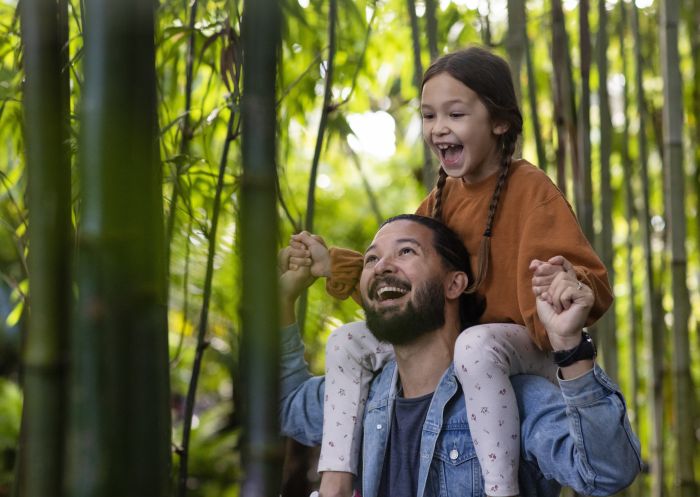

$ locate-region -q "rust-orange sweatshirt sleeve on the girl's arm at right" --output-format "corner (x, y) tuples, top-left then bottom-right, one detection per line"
(517, 193), (613, 350)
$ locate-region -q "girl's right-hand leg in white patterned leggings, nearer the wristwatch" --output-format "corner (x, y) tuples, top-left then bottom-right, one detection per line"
(455, 323), (556, 496)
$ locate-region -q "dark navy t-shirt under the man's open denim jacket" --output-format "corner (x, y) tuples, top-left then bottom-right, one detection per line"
(379, 393), (433, 497)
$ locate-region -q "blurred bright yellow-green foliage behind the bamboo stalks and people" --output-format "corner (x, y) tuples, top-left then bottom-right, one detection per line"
(0, 0), (700, 496)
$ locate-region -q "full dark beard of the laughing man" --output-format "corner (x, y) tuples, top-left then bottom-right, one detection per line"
(362, 278), (445, 345)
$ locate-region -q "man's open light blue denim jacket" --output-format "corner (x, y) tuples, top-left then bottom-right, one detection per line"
(280, 325), (641, 497)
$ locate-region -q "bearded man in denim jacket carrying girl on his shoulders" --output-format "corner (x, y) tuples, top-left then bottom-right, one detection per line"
(280, 215), (640, 497)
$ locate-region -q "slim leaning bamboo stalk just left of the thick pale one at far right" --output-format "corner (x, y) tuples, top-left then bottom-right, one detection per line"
(631, 5), (666, 497)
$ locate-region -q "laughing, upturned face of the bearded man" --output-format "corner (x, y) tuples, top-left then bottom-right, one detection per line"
(360, 220), (445, 345)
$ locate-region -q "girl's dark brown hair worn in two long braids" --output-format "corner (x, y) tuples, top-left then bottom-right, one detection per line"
(421, 47), (523, 291)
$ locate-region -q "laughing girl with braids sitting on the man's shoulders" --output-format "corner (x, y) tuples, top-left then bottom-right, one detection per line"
(289, 47), (612, 497)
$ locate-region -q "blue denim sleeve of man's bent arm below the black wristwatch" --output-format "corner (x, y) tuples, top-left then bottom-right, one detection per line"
(512, 365), (641, 495)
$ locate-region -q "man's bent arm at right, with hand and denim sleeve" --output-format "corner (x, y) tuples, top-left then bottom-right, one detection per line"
(524, 261), (641, 495)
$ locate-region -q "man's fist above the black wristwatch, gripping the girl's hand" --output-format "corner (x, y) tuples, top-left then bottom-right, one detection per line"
(530, 261), (595, 350)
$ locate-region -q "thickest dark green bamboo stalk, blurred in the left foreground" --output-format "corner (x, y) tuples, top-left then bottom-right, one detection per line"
(67, 0), (171, 497)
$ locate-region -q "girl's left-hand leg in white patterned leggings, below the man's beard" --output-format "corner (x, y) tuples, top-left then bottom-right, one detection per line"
(318, 321), (394, 474)
